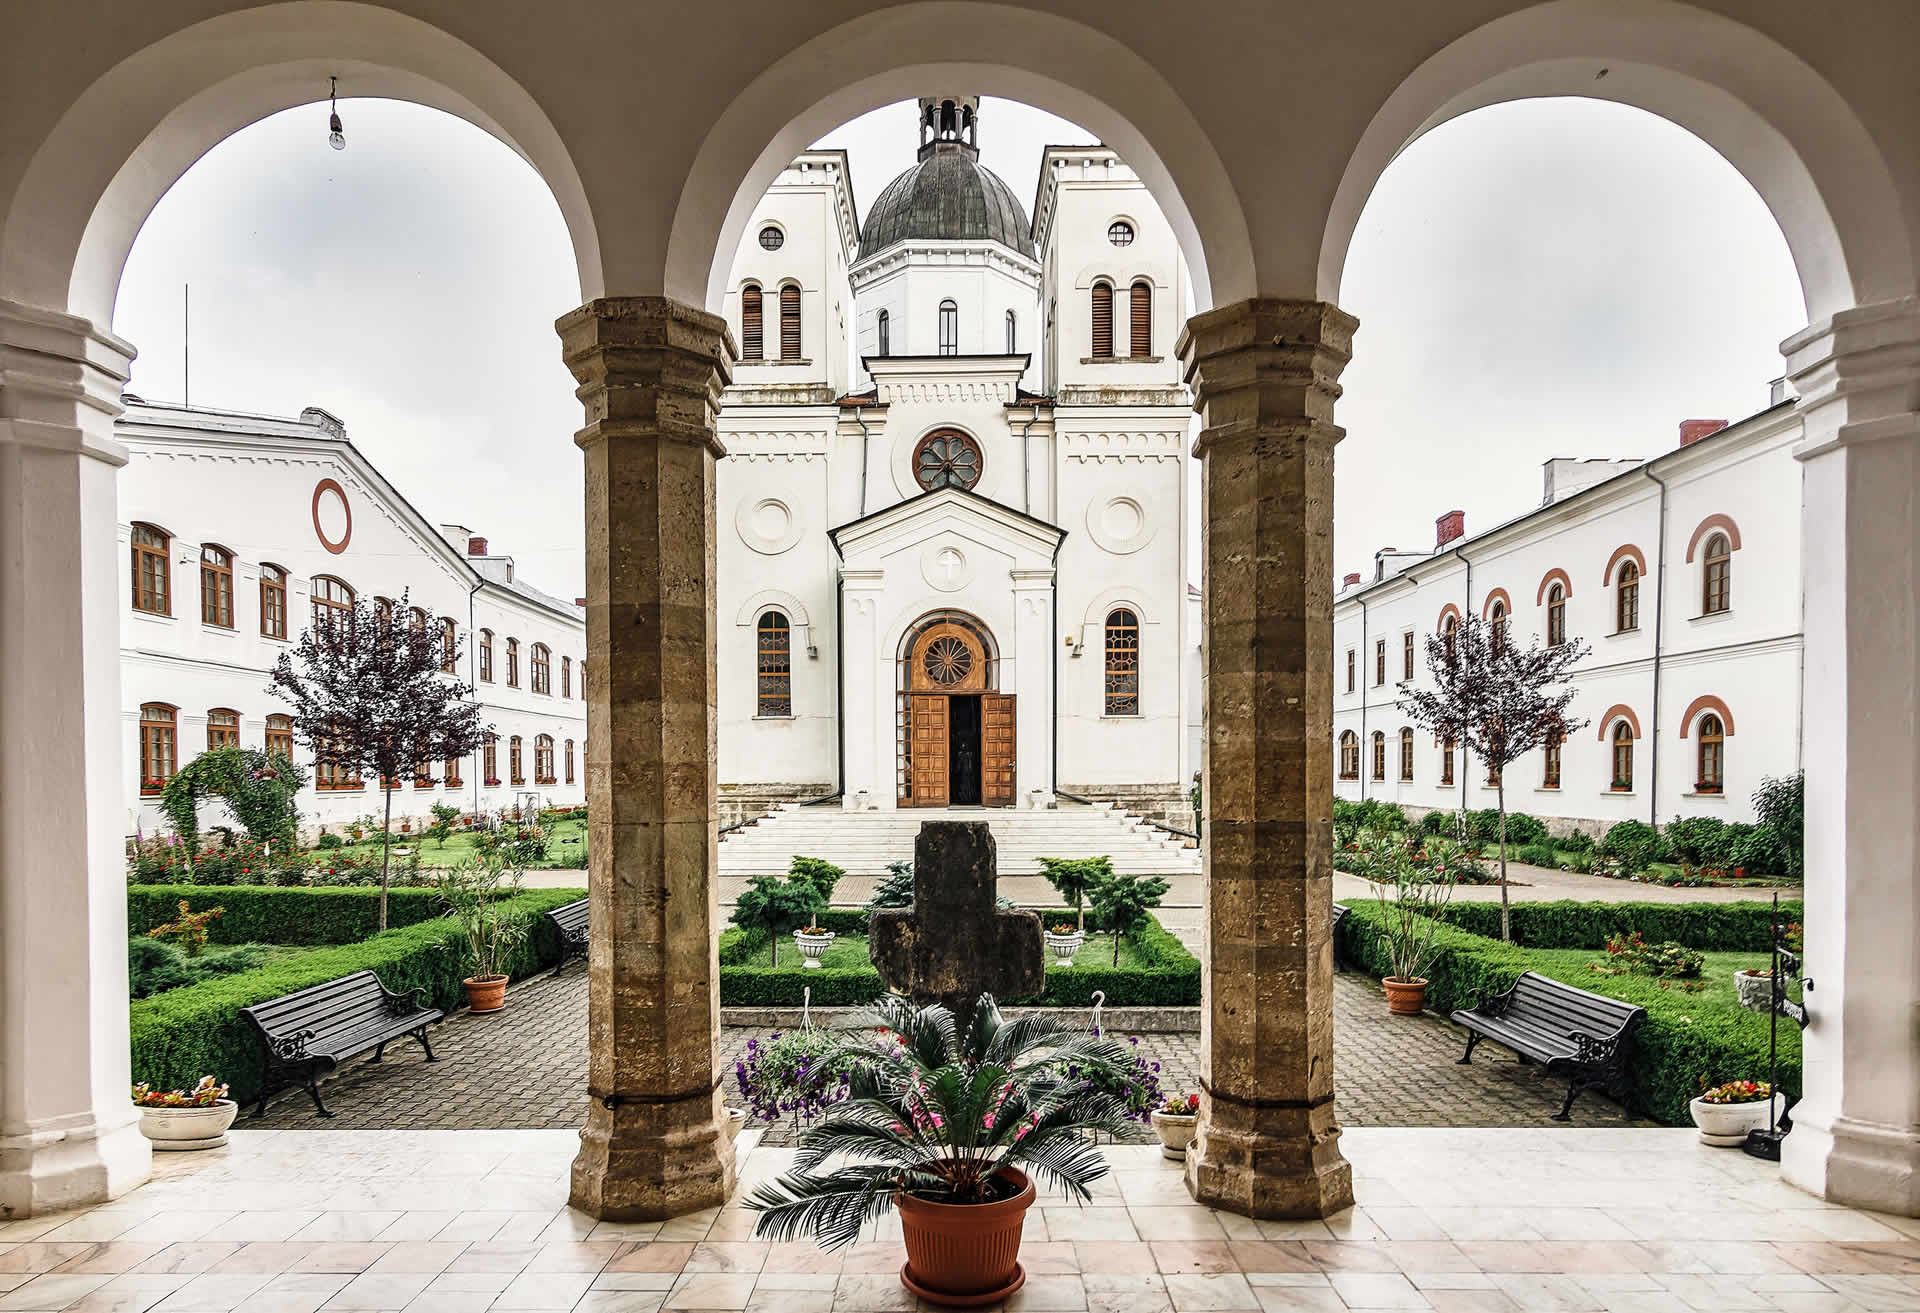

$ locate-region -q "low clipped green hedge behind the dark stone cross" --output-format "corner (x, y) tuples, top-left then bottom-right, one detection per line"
(720, 908), (1200, 1008)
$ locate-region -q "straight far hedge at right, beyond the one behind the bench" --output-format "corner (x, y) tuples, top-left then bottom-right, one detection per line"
(1440, 902), (1803, 952)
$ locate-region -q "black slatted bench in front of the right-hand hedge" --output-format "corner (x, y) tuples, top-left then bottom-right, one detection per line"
(1453, 971), (1647, 1121)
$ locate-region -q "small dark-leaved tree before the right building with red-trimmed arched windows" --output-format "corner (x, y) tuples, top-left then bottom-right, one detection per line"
(1400, 616), (1588, 941)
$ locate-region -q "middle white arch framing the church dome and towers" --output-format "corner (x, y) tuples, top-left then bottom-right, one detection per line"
(664, 0), (1258, 311)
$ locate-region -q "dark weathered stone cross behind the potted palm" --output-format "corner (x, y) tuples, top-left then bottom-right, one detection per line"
(868, 822), (1046, 1031)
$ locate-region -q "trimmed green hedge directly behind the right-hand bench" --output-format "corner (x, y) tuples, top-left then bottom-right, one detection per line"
(1340, 902), (1801, 1127)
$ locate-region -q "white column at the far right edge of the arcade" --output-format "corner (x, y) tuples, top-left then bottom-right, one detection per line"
(1774, 298), (1920, 1217)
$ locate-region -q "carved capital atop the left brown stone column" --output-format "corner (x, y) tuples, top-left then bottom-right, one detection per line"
(553, 296), (735, 457)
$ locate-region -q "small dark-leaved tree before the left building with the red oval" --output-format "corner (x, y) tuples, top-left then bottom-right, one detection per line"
(267, 593), (493, 929)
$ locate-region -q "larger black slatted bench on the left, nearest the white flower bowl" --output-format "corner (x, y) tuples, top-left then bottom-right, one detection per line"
(240, 971), (445, 1117)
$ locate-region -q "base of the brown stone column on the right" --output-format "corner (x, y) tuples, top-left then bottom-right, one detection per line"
(1187, 1098), (1354, 1219)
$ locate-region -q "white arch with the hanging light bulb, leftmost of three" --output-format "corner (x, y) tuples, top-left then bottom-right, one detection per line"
(0, 0), (605, 326)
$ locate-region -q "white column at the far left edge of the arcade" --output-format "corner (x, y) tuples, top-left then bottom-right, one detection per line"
(0, 301), (152, 1219)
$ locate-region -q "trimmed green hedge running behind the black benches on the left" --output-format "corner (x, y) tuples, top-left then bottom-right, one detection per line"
(131, 889), (580, 1102)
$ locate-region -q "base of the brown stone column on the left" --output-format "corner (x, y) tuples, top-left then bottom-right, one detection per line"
(566, 1096), (735, 1221)
